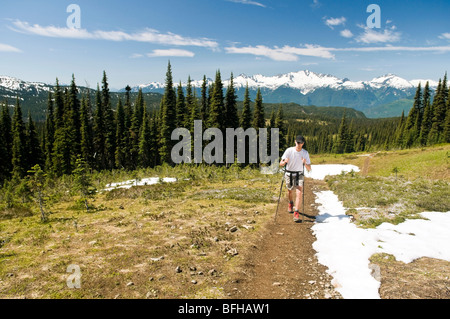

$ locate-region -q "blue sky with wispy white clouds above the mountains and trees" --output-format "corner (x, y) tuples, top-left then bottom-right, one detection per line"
(0, 0), (450, 89)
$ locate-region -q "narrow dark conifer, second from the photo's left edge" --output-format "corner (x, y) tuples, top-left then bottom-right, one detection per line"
(12, 97), (27, 178)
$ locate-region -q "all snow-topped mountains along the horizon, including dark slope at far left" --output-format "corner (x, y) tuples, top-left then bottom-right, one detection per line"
(0, 70), (438, 118)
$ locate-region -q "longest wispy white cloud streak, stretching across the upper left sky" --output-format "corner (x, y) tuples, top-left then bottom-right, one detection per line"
(11, 20), (219, 49)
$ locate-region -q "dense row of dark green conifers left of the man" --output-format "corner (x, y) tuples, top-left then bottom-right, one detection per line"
(0, 62), (284, 185)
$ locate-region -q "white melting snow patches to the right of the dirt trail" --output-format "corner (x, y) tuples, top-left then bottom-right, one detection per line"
(306, 165), (450, 299)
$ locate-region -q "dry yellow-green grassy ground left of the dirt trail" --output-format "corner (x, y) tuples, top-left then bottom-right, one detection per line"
(0, 171), (279, 298)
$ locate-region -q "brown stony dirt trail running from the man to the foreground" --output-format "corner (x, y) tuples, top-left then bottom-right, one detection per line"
(225, 179), (341, 299)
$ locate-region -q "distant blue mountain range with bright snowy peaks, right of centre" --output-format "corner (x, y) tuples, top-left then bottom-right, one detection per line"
(126, 70), (438, 118)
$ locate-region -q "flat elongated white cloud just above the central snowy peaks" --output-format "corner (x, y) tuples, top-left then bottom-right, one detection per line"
(225, 44), (334, 62)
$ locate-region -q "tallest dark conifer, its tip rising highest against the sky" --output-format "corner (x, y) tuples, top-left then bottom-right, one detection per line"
(159, 61), (177, 163)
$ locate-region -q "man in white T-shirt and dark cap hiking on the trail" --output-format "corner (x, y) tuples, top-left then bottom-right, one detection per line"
(280, 135), (311, 222)
